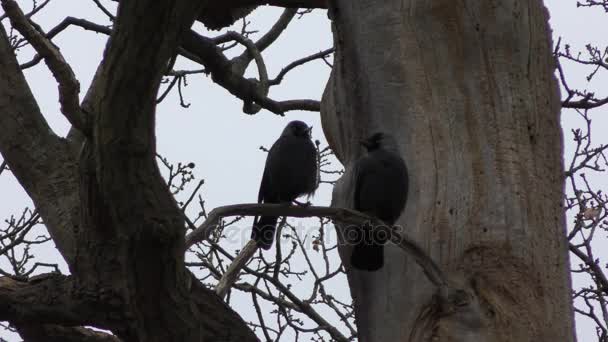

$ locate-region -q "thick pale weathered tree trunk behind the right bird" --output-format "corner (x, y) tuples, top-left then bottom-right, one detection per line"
(322, 0), (574, 342)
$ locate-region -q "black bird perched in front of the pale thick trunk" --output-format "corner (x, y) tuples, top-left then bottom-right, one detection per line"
(350, 132), (408, 271)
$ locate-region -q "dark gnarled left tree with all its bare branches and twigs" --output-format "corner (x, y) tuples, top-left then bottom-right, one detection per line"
(0, 1), (355, 341)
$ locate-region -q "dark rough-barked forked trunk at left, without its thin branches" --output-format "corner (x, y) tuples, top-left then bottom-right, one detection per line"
(0, 0), (257, 341)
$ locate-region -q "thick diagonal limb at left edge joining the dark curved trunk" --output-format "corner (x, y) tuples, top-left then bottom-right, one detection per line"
(0, 22), (79, 267)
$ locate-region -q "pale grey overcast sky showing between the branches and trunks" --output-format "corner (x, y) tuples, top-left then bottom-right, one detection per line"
(0, 0), (608, 341)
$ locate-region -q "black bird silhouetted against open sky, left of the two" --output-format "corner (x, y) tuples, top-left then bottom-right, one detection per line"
(251, 120), (319, 249)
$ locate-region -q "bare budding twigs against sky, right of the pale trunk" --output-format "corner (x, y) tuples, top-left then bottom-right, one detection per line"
(554, 0), (608, 342)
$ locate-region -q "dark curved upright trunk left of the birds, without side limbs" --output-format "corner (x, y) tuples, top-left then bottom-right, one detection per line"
(78, 0), (255, 342)
